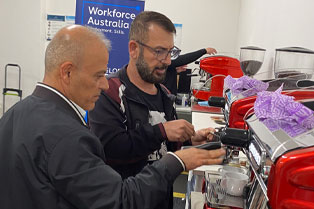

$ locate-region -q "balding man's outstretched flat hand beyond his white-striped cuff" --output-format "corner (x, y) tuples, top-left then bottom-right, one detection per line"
(175, 148), (226, 171)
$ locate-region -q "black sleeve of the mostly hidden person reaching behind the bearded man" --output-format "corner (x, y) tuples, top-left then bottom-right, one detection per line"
(163, 49), (207, 95)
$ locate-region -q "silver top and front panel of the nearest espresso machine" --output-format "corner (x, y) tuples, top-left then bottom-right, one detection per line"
(243, 115), (314, 209)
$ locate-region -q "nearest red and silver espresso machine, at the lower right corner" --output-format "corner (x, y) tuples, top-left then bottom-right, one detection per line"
(204, 99), (314, 209)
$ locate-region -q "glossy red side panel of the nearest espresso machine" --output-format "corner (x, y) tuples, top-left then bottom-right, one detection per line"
(267, 147), (314, 209)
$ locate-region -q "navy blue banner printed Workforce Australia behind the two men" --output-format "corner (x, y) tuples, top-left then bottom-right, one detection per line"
(75, 0), (145, 74)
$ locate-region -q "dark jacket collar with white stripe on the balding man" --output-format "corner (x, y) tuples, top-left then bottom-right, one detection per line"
(32, 83), (87, 127)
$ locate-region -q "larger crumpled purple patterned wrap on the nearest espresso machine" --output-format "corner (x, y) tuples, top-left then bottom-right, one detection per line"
(254, 86), (314, 137)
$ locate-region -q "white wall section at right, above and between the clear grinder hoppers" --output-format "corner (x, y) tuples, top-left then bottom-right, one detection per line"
(237, 0), (314, 78)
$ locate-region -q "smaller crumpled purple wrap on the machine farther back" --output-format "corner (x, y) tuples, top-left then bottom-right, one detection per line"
(224, 75), (268, 97)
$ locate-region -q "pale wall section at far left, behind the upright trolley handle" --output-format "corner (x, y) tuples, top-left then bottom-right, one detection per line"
(0, 0), (45, 115)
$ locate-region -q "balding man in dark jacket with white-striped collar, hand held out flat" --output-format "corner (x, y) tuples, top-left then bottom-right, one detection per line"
(0, 25), (224, 209)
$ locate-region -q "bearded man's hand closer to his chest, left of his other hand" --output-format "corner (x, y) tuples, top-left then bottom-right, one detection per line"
(163, 119), (195, 142)
